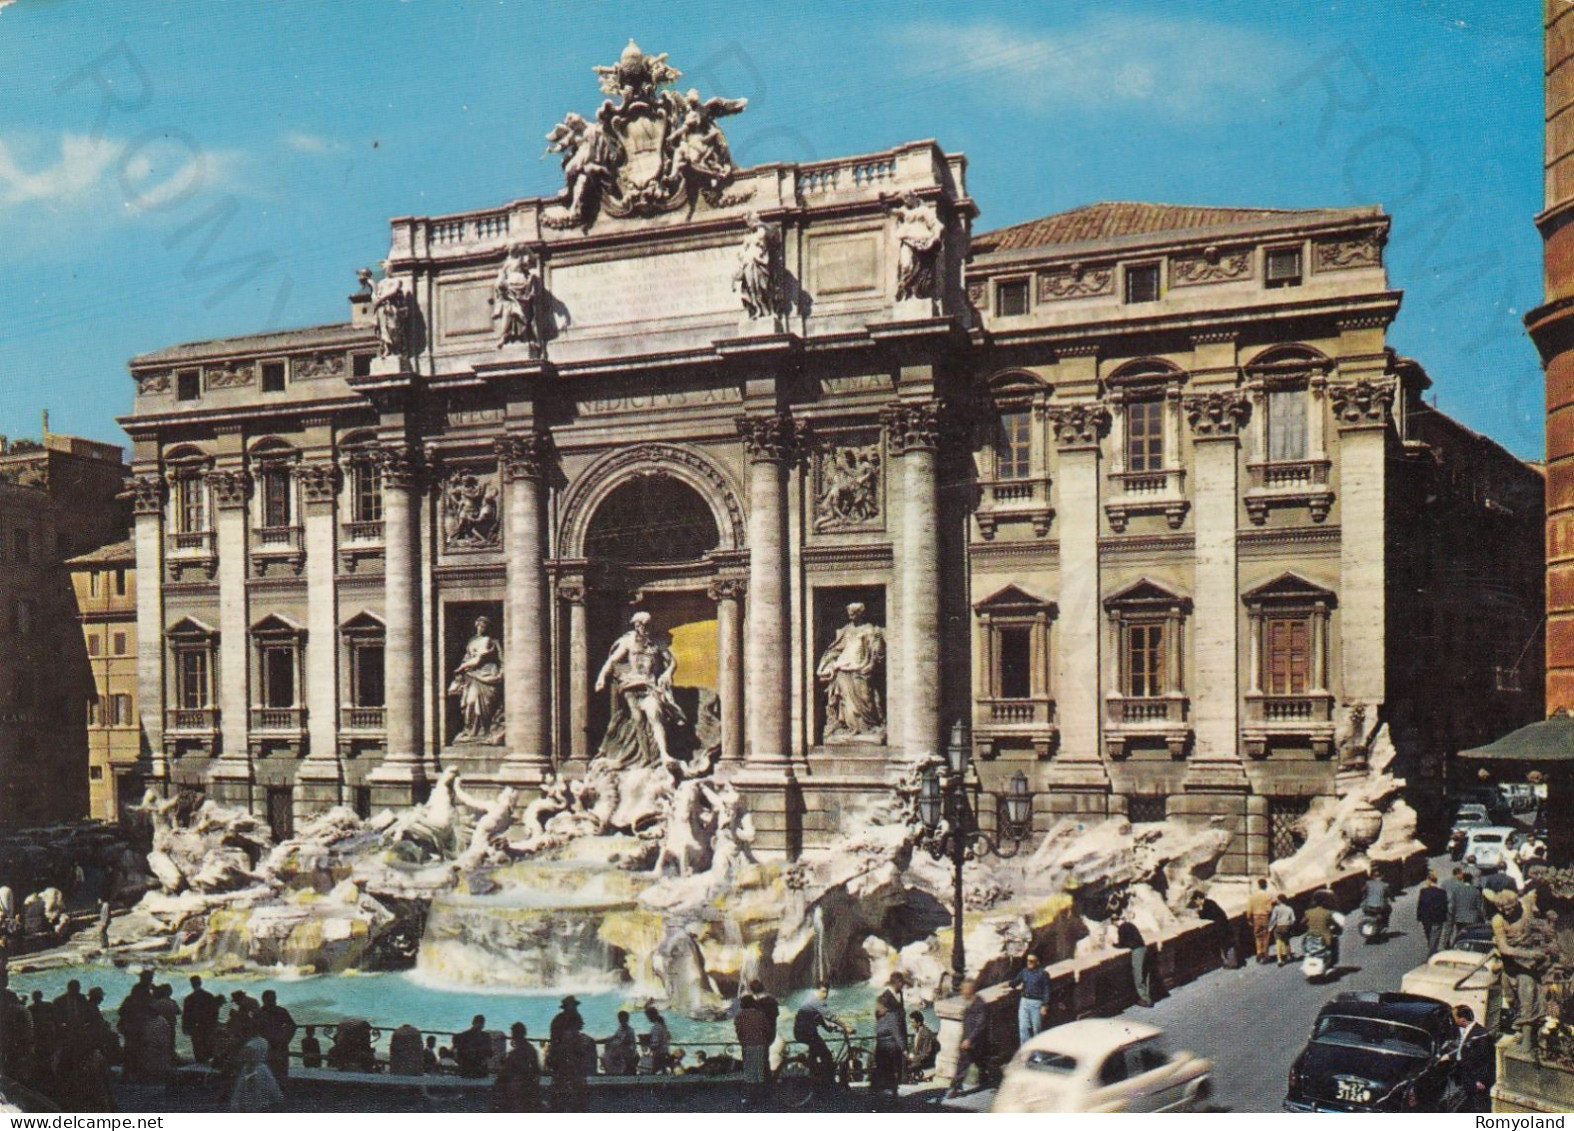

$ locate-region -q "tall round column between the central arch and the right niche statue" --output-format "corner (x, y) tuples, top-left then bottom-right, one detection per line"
(738, 412), (798, 766)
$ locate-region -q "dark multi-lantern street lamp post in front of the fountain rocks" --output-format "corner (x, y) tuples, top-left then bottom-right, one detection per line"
(918, 719), (1033, 993)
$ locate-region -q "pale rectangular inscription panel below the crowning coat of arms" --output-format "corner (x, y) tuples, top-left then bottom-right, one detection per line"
(549, 245), (743, 332)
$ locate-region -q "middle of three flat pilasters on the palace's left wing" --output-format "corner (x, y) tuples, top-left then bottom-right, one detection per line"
(208, 467), (252, 807)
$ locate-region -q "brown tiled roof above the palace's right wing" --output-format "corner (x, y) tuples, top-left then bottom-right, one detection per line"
(973, 200), (1382, 252)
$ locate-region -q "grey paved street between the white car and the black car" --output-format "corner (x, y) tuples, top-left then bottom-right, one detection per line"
(1121, 859), (1447, 1112)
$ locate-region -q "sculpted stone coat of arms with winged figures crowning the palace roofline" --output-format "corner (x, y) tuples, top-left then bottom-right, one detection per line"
(543, 39), (748, 228)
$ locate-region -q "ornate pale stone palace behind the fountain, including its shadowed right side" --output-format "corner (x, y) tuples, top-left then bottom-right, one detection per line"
(123, 46), (1541, 871)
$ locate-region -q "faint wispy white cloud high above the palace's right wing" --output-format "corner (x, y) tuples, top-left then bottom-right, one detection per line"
(897, 14), (1283, 118)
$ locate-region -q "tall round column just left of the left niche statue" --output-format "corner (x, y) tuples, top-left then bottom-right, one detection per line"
(368, 447), (422, 804)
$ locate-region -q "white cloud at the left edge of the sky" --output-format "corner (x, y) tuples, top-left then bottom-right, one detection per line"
(0, 134), (241, 216)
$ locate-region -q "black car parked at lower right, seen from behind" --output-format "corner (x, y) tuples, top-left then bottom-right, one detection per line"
(1284, 993), (1465, 1112)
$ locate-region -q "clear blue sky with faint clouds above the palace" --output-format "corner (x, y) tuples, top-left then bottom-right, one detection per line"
(0, 0), (1543, 458)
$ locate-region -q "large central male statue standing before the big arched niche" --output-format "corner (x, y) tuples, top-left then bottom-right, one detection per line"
(595, 612), (686, 769)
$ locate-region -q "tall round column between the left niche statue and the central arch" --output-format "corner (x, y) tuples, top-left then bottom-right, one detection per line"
(497, 436), (552, 782)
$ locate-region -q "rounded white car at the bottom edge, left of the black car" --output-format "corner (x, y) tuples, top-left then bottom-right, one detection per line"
(990, 1018), (1214, 1112)
